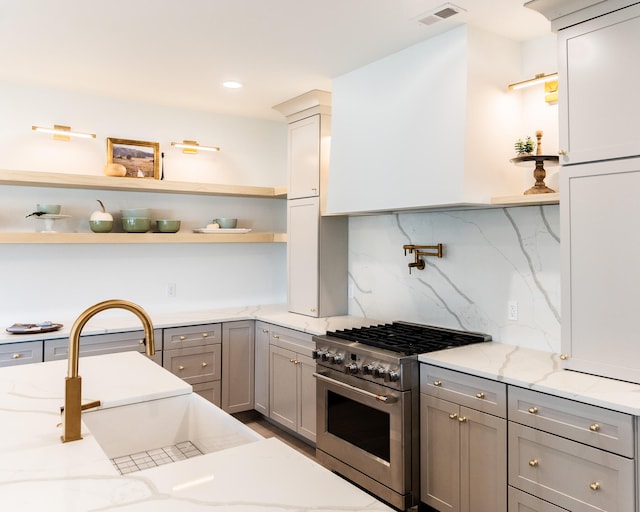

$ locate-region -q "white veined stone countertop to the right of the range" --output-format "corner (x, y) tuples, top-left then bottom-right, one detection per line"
(418, 342), (640, 416)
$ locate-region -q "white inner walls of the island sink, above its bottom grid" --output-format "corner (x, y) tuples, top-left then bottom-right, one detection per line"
(82, 393), (263, 459)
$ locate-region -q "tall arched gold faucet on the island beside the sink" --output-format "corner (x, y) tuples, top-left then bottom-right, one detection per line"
(60, 299), (155, 443)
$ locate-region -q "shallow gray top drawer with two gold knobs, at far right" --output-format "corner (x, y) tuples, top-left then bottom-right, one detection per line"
(509, 386), (634, 457)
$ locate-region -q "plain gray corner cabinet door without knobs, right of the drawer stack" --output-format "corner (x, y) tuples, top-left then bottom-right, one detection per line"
(222, 320), (255, 413)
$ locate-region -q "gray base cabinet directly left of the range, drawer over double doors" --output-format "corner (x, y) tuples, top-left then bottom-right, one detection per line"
(269, 326), (316, 443)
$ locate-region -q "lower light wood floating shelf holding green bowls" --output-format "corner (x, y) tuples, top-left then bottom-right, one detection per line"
(0, 232), (287, 244)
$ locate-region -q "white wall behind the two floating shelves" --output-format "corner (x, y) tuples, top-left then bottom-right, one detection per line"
(0, 83), (287, 325)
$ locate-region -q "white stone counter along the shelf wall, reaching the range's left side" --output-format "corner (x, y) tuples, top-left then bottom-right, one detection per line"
(0, 304), (381, 345)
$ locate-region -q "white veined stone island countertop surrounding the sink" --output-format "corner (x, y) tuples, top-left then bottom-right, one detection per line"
(0, 352), (391, 512)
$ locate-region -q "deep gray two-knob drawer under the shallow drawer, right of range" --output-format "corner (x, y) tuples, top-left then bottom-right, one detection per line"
(508, 422), (635, 512)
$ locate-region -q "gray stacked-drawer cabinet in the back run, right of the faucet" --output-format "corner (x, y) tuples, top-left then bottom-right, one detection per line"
(163, 324), (222, 406)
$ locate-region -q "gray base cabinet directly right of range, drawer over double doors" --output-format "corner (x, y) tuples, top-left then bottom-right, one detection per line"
(420, 365), (507, 512)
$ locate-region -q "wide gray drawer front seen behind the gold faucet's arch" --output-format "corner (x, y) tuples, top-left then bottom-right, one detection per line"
(44, 329), (162, 362)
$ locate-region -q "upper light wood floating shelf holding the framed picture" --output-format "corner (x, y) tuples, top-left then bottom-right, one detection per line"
(0, 170), (287, 199)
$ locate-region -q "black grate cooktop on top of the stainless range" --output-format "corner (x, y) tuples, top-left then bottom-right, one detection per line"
(327, 322), (491, 356)
